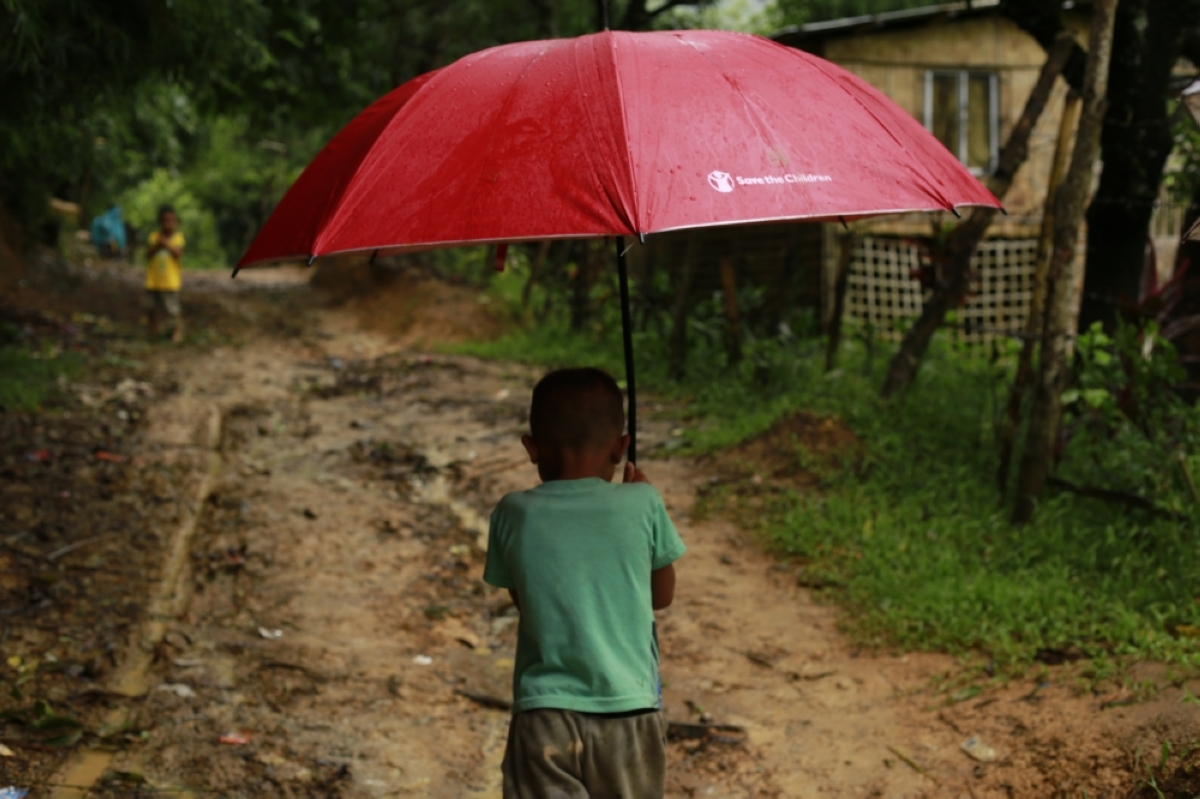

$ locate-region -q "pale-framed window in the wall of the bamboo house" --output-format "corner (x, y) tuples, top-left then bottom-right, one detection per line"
(925, 70), (1000, 175)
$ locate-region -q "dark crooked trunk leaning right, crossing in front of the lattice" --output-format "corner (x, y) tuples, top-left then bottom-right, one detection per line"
(882, 34), (1076, 400)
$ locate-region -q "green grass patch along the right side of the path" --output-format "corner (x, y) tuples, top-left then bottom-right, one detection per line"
(462, 307), (1200, 672)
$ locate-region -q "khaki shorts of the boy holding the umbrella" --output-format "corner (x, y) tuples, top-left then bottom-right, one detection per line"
(502, 709), (667, 799)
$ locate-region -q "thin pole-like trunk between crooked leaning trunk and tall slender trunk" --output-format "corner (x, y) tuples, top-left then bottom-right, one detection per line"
(996, 89), (1080, 493)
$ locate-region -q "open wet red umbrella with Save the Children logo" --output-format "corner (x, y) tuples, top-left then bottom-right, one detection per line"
(234, 30), (1000, 459)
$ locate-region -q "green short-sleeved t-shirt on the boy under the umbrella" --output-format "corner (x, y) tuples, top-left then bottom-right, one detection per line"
(484, 477), (685, 713)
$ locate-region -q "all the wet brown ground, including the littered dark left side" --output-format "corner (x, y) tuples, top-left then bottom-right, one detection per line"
(0, 257), (1200, 799)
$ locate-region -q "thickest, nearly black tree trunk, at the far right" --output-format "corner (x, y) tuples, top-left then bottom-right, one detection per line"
(1079, 0), (1200, 329)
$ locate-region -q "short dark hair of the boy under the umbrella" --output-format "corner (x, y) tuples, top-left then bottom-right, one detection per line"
(529, 367), (625, 450)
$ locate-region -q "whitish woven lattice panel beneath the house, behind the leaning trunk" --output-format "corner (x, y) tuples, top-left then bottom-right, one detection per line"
(846, 231), (1037, 344)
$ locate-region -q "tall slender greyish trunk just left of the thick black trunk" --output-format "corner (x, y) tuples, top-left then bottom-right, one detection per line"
(1013, 0), (1117, 524)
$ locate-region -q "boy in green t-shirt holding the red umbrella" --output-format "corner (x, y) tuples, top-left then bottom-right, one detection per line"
(484, 368), (684, 799)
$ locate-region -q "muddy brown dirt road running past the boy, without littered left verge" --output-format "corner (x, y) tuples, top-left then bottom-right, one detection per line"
(4, 262), (1198, 799)
